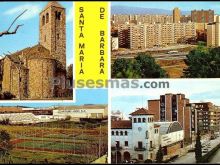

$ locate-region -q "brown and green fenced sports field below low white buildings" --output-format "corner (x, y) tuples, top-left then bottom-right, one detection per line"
(0, 121), (108, 163)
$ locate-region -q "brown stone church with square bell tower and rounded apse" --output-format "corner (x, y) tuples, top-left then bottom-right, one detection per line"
(1, 1), (69, 99)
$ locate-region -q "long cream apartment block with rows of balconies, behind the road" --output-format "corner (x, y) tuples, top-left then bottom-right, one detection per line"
(118, 22), (196, 49)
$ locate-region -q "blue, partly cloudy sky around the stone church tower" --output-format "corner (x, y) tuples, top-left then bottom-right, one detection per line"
(0, 1), (73, 65)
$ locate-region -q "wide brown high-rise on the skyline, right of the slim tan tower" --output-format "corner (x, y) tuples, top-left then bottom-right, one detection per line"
(191, 10), (214, 23)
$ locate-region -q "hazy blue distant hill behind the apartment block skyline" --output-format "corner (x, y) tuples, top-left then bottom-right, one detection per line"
(111, 6), (191, 15)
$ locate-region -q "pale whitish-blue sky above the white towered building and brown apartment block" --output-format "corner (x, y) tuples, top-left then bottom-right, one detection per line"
(110, 79), (220, 117)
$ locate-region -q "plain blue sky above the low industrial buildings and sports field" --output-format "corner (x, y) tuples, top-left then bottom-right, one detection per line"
(0, 89), (108, 107)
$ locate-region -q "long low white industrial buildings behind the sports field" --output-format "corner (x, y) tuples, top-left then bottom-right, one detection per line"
(0, 104), (108, 124)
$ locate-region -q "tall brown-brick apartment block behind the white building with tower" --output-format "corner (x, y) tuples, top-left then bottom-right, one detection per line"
(148, 93), (191, 139)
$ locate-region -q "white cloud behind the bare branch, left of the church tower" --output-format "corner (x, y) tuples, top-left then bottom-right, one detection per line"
(4, 3), (41, 20)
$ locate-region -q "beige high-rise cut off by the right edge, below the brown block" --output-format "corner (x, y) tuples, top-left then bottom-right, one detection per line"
(207, 16), (220, 47)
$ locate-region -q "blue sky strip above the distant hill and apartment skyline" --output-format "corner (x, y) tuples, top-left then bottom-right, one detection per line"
(111, 1), (220, 14)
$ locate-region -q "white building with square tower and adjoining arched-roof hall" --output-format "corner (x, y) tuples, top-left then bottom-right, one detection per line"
(111, 108), (184, 163)
